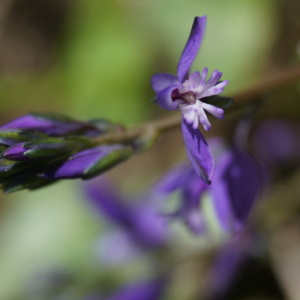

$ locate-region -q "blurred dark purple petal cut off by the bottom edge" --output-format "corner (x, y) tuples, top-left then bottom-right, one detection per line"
(107, 278), (165, 300)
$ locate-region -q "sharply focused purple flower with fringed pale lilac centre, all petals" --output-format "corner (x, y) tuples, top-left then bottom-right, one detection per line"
(151, 16), (228, 183)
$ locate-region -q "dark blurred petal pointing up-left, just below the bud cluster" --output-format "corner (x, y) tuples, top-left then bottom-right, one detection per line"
(86, 178), (132, 226)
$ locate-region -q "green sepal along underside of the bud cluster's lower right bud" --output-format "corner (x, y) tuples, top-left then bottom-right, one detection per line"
(82, 146), (134, 179)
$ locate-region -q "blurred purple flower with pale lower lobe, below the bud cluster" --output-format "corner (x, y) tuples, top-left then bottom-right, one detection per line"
(86, 178), (168, 264)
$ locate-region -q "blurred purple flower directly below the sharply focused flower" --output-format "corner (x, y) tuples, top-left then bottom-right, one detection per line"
(157, 142), (262, 235)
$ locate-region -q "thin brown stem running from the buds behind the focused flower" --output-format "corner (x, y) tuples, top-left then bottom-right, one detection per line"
(94, 65), (300, 144)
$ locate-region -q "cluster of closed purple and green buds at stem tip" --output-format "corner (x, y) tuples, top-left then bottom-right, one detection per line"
(0, 113), (133, 193)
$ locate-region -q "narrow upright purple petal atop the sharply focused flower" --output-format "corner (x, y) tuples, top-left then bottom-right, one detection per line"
(177, 16), (206, 82)
